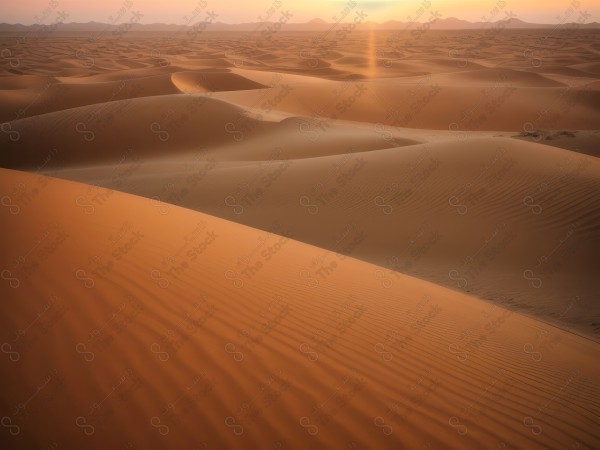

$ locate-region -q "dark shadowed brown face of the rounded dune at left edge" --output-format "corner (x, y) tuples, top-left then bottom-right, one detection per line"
(2, 94), (276, 167)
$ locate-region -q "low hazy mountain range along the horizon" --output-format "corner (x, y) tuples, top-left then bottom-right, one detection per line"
(0, 17), (600, 35)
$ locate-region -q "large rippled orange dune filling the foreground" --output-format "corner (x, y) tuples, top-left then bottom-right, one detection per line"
(0, 170), (600, 449)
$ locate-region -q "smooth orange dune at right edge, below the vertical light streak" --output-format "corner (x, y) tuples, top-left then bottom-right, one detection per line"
(211, 66), (600, 131)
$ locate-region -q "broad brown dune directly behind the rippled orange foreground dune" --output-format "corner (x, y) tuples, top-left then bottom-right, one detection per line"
(38, 135), (600, 340)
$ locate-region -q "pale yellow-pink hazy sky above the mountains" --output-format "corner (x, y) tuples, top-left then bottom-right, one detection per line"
(0, 0), (600, 24)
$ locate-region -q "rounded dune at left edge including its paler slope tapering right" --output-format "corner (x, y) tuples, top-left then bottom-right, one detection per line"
(0, 92), (432, 170)
